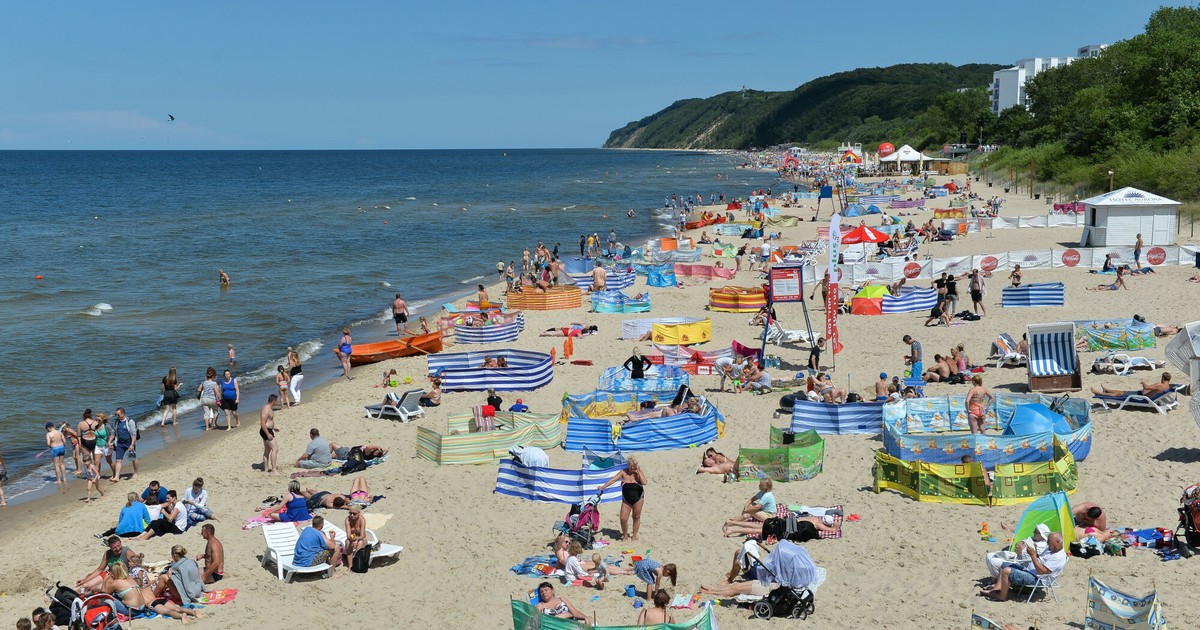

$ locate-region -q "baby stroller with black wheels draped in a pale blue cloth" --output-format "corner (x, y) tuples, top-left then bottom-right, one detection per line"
(748, 540), (817, 620)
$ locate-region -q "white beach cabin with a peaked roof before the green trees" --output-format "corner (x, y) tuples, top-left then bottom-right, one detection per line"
(1082, 187), (1180, 247)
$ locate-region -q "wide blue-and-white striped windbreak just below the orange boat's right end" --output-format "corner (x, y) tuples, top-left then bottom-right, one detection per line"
(427, 349), (554, 391)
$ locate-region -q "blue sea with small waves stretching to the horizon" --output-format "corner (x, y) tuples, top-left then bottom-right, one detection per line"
(0, 149), (778, 502)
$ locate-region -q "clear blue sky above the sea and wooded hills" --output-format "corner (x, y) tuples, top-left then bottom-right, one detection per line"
(0, 0), (1172, 149)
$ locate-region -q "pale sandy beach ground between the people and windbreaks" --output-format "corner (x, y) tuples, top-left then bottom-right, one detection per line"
(0, 176), (1200, 629)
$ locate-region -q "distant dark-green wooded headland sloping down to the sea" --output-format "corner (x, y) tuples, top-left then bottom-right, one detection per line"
(605, 64), (1004, 149)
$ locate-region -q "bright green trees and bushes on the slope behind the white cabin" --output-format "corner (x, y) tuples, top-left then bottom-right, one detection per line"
(979, 7), (1200, 200)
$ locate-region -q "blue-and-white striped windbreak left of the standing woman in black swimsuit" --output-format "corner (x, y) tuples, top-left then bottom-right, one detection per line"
(496, 460), (625, 504)
